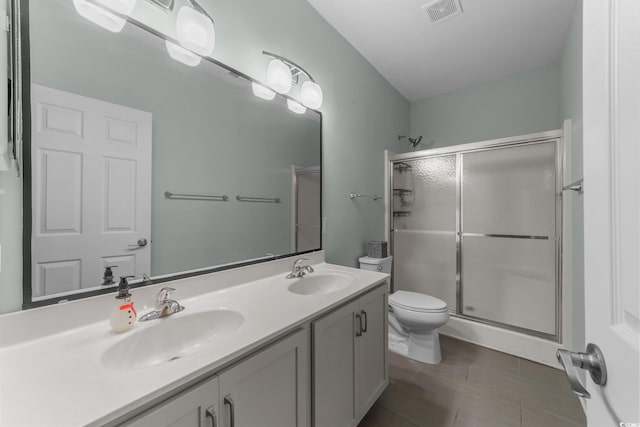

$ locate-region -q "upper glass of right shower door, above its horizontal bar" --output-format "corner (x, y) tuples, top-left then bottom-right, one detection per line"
(462, 142), (556, 236)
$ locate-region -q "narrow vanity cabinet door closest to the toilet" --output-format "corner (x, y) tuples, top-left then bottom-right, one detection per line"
(357, 286), (389, 415)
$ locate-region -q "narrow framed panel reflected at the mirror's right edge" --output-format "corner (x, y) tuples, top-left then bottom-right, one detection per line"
(292, 166), (321, 252)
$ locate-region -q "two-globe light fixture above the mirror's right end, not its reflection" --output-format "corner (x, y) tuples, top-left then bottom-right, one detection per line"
(262, 51), (323, 108)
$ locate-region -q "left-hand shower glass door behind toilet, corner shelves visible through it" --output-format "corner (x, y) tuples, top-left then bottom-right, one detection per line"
(392, 154), (458, 310)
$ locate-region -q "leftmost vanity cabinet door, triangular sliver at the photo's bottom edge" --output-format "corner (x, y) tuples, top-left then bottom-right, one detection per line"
(124, 377), (219, 427)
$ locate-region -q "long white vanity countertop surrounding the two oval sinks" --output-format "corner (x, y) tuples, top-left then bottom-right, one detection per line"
(0, 259), (387, 427)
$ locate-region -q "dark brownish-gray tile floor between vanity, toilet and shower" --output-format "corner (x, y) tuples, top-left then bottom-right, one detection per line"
(358, 336), (586, 427)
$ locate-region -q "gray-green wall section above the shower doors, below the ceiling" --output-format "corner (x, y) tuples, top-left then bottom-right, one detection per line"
(410, 63), (562, 149)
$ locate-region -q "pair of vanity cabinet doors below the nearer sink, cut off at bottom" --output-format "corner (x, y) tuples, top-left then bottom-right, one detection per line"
(124, 329), (311, 427)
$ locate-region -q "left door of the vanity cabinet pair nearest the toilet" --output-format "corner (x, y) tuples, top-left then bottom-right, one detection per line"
(312, 301), (359, 427)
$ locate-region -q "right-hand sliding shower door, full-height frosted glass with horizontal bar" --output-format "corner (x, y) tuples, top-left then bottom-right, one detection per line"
(460, 140), (559, 336)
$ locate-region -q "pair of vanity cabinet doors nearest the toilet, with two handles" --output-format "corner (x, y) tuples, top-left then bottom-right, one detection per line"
(312, 284), (389, 427)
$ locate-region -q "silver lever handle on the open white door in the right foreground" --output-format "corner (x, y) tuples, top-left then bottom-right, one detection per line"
(556, 343), (607, 399)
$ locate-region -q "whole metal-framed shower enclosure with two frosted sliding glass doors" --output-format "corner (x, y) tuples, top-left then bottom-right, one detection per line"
(388, 133), (563, 341)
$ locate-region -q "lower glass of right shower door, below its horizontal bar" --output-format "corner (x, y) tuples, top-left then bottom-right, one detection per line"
(462, 236), (556, 334)
